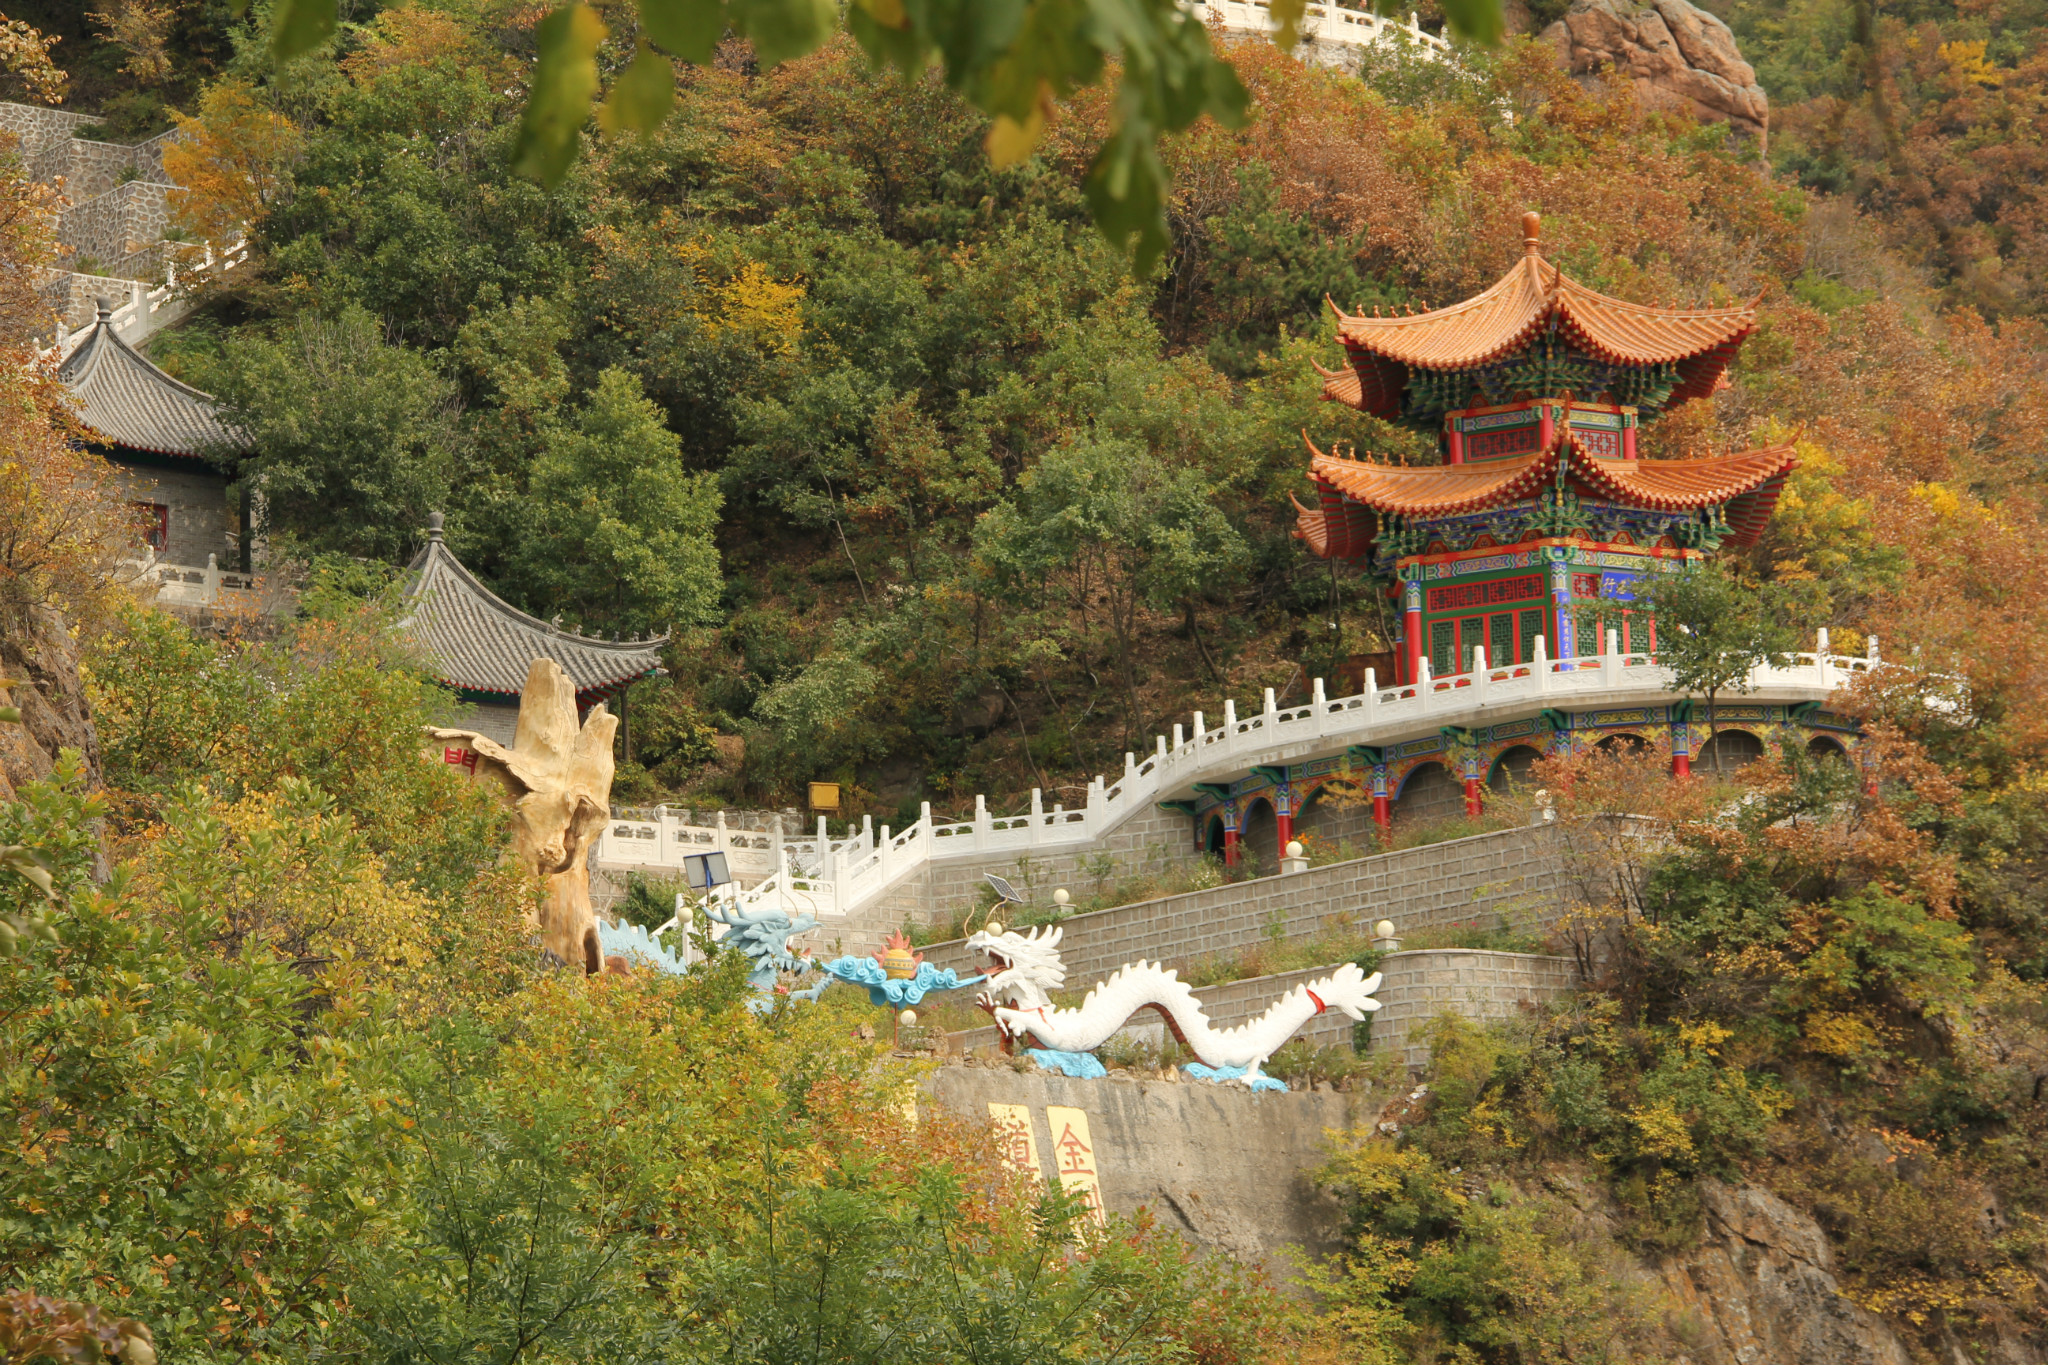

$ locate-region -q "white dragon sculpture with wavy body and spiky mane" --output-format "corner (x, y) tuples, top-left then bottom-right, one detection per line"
(967, 925), (1380, 1085)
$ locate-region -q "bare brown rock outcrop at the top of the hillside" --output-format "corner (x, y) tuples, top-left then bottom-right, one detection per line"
(1540, 0), (1772, 141)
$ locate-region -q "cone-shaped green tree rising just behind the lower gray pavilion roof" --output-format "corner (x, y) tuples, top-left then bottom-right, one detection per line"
(508, 368), (723, 634)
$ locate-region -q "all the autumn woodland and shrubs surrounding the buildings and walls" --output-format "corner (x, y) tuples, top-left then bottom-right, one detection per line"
(12, 0), (2048, 1365)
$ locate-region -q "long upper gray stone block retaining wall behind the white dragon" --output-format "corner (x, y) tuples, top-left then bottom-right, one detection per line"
(924, 829), (1565, 988)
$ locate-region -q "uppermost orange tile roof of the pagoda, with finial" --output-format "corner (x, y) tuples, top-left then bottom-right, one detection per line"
(1331, 213), (1757, 376)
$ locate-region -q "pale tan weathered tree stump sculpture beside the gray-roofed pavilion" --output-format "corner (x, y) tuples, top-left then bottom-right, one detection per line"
(428, 659), (618, 974)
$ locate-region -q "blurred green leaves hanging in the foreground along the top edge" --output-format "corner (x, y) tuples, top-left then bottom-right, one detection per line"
(229, 0), (1503, 276)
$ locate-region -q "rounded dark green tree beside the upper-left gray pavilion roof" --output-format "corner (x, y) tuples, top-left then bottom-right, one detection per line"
(215, 307), (463, 559)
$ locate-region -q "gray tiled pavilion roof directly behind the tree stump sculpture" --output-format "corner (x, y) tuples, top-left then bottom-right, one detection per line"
(399, 512), (668, 696)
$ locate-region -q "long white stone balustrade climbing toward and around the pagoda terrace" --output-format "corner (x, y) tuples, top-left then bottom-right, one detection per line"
(596, 630), (1878, 917)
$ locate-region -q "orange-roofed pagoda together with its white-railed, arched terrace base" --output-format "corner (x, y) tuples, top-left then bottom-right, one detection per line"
(1159, 213), (1855, 875)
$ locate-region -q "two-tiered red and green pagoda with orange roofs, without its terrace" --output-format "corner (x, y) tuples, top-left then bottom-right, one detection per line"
(1294, 213), (1794, 684)
